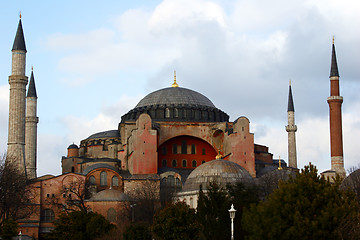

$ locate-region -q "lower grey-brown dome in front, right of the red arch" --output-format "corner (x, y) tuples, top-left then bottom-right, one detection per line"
(183, 159), (254, 192)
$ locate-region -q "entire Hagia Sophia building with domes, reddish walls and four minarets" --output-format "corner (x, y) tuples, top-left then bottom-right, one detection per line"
(7, 16), (345, 238)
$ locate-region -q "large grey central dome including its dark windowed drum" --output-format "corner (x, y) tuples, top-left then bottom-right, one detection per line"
(121, 87), (229, 122)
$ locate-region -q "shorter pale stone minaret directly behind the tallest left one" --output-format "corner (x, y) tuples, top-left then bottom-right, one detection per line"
(25, 68), (39, 179)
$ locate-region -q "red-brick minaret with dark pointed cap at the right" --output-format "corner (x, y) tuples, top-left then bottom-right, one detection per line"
(327, 38), (346, 177)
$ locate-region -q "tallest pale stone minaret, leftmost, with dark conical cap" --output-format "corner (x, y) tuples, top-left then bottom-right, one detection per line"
(7, 14), (28, 172)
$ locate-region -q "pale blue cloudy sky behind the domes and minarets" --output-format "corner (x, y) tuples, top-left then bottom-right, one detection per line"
(0, 0), (360, 176)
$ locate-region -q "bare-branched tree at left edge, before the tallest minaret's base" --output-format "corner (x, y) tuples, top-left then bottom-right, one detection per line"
(0, 154), (34, 225)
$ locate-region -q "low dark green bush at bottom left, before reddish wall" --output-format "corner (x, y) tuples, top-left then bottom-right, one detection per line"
(46, 211), (114, 240)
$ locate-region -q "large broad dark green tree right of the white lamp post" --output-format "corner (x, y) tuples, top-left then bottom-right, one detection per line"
(243, 164), (358, 240)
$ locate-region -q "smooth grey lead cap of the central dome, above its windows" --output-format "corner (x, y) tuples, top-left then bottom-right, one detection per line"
(135, 87), (215, 108)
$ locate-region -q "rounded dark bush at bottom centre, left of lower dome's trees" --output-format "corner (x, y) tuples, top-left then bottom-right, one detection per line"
(152, 202), (200, 240)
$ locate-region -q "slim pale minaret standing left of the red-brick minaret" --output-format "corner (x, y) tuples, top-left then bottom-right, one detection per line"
(286, 81), (297, 168)
